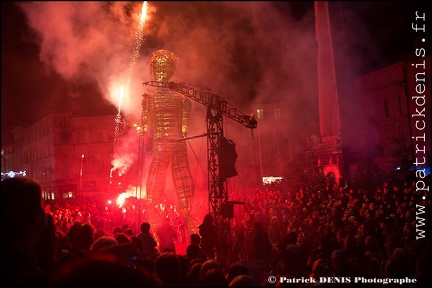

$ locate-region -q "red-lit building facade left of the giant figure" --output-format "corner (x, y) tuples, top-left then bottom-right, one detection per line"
(2, 113), (115, 199)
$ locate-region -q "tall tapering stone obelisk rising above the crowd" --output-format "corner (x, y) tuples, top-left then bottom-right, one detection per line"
(314, 1), (362, 182)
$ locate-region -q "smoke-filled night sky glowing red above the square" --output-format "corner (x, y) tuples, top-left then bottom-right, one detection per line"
(1, 1), (428, 146)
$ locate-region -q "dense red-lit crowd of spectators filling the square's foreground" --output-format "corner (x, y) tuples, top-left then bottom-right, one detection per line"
(1, 178), (432, 287)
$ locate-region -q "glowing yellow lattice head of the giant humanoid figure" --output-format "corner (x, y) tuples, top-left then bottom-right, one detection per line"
(150, 49), (177, 82)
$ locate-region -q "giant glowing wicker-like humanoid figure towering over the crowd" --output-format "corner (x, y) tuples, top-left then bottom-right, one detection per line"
(141, 49), (194, 214)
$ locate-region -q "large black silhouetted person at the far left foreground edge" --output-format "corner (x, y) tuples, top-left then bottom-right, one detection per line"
(0, 177), (49, 287)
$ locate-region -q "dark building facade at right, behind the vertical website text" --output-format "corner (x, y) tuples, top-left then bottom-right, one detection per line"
(356, 56), (431, 171)
